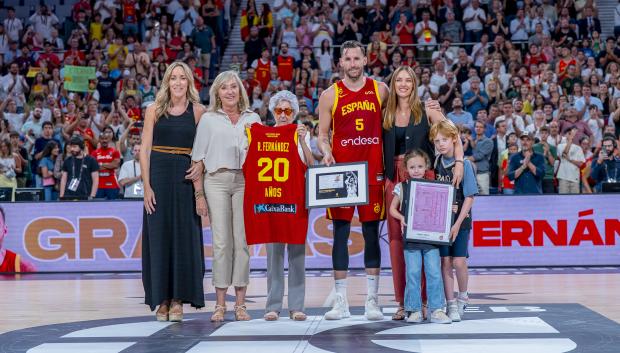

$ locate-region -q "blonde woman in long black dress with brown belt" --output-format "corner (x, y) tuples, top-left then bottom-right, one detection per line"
(140, 62), (207, 321)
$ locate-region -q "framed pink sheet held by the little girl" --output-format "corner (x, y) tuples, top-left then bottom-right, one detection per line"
(405, 179), (455, 245)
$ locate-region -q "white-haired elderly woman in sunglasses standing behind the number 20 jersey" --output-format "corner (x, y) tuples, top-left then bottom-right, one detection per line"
(264, 91), (314, 321)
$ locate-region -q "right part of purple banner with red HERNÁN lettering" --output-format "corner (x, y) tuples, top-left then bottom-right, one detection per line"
(469, 194), (620, 266)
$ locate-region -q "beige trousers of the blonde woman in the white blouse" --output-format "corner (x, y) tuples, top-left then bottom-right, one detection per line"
(204, 169), (250, 288)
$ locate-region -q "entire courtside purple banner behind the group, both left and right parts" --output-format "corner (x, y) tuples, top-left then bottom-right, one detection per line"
(0, 194), (620, 272)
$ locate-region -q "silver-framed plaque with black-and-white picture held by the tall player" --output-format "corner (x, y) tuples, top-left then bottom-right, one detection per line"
(306, 162), (368, 208)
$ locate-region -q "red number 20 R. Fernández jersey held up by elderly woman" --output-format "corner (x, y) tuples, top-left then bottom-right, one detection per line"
(243, 124), (308, 245)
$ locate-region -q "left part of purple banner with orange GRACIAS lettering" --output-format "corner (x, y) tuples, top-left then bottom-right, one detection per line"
(0, 201), (378, 272)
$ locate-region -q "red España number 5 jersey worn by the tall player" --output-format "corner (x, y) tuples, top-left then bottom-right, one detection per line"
(332, 78), (383, 185)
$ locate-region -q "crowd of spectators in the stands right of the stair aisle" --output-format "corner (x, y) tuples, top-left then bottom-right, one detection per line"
(237, 0), (620, 194)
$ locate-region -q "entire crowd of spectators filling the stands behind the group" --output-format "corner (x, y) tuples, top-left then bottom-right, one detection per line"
(0, 0), (620, 200)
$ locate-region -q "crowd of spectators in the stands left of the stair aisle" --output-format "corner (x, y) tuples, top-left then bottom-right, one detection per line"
(0, 0), (239, 200)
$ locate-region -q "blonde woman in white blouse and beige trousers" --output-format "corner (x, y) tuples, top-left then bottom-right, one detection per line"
(192, 71), (261, 322)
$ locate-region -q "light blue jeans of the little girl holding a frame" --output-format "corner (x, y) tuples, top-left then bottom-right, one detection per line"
(405, 248), (446, 313)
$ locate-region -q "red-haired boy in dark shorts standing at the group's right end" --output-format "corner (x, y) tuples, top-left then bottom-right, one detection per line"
(430, 120), (478, 322)
